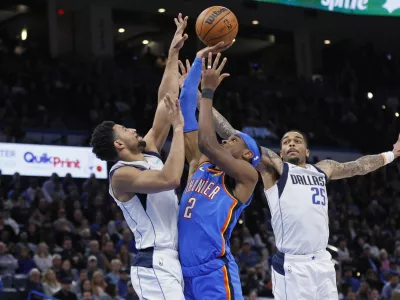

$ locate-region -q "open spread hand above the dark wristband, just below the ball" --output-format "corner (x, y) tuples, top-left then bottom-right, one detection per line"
(201, 52), (230, 91)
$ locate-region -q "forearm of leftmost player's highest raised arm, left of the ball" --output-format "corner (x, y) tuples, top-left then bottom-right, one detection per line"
(158, 49), (179, 102)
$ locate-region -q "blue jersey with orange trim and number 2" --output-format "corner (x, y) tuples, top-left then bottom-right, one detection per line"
(178, 162), (253, 267)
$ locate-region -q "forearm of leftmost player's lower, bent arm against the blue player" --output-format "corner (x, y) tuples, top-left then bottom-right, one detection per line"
(163, 127), (185, 185)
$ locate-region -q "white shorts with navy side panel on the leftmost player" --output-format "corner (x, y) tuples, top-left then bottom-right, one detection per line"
(131, 249), (185, 300)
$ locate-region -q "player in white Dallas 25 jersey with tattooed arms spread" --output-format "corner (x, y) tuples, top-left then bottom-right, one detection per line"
(180, 63), (400, 300)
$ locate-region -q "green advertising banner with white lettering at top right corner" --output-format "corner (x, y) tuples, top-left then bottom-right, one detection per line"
(256, 0), (400, 17)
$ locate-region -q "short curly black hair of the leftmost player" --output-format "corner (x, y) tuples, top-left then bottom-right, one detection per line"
(90, 121), (118, 161)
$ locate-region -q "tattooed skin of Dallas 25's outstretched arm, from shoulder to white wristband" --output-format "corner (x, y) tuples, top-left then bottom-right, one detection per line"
(317, 154), (385, 180)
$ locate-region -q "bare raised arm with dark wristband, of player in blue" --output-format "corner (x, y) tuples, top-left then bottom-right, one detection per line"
(199, 54), (258, 202)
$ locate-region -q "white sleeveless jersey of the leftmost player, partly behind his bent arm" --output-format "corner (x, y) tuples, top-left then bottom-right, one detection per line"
(109, 153), (179, 250)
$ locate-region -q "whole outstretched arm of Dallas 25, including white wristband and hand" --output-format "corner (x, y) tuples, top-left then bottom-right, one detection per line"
(316, 136), (400, 180)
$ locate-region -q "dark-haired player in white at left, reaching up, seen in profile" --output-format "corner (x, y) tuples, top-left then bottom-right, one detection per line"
(91, 14), (187, 300)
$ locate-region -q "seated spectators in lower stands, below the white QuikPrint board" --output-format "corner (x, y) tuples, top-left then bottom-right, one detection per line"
(0, 158), (400, 300)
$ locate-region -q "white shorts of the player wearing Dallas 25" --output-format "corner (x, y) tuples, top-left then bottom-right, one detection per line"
(272, 250), (339, 300)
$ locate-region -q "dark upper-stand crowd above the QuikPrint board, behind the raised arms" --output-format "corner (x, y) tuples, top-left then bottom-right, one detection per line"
(0, 41), (400, 152)
